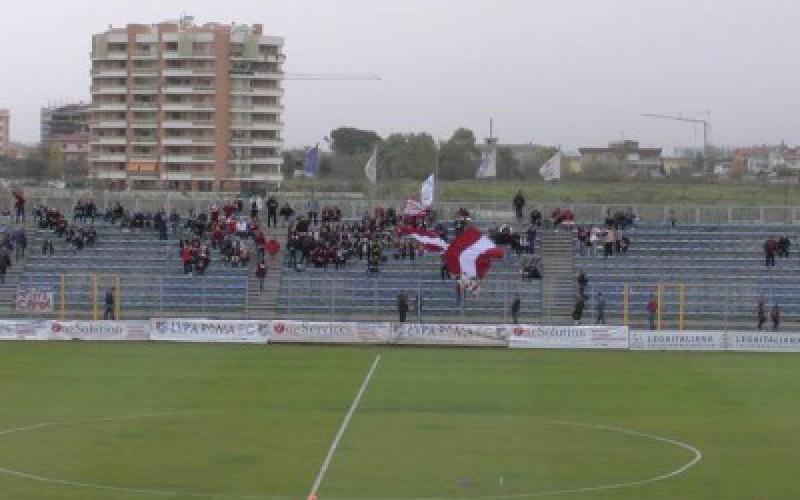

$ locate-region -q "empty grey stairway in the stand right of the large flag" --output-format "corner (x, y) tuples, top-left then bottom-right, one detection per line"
(541, 229), (576, 325)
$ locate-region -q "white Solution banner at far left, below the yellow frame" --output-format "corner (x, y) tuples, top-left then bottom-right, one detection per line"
(36, 321), (150, 340)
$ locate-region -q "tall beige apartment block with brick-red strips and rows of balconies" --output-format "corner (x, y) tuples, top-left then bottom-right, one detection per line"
(89, 18), (284, 192)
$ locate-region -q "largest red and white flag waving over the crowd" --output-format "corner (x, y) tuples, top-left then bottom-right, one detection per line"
(444, 227), (505, 279)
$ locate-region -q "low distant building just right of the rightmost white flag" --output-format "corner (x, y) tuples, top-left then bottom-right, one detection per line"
(578, 141), (664, 177)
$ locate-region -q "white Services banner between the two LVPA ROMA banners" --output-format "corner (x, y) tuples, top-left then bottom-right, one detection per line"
(269, 320), (389, 344)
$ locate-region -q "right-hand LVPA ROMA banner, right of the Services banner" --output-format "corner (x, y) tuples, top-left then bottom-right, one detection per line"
(392, 323), (510, 347)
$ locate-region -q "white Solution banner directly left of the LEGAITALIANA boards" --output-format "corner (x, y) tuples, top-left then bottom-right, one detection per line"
(508, 325), (628, 349)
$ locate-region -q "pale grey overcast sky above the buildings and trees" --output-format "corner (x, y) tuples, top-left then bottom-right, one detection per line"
(0, 0), (800, 149)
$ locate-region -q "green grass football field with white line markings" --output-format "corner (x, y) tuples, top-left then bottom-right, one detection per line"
(0, 342), (800, 500)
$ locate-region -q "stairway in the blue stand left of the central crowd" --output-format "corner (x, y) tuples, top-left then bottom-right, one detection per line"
(247, 227), (286, 319)
